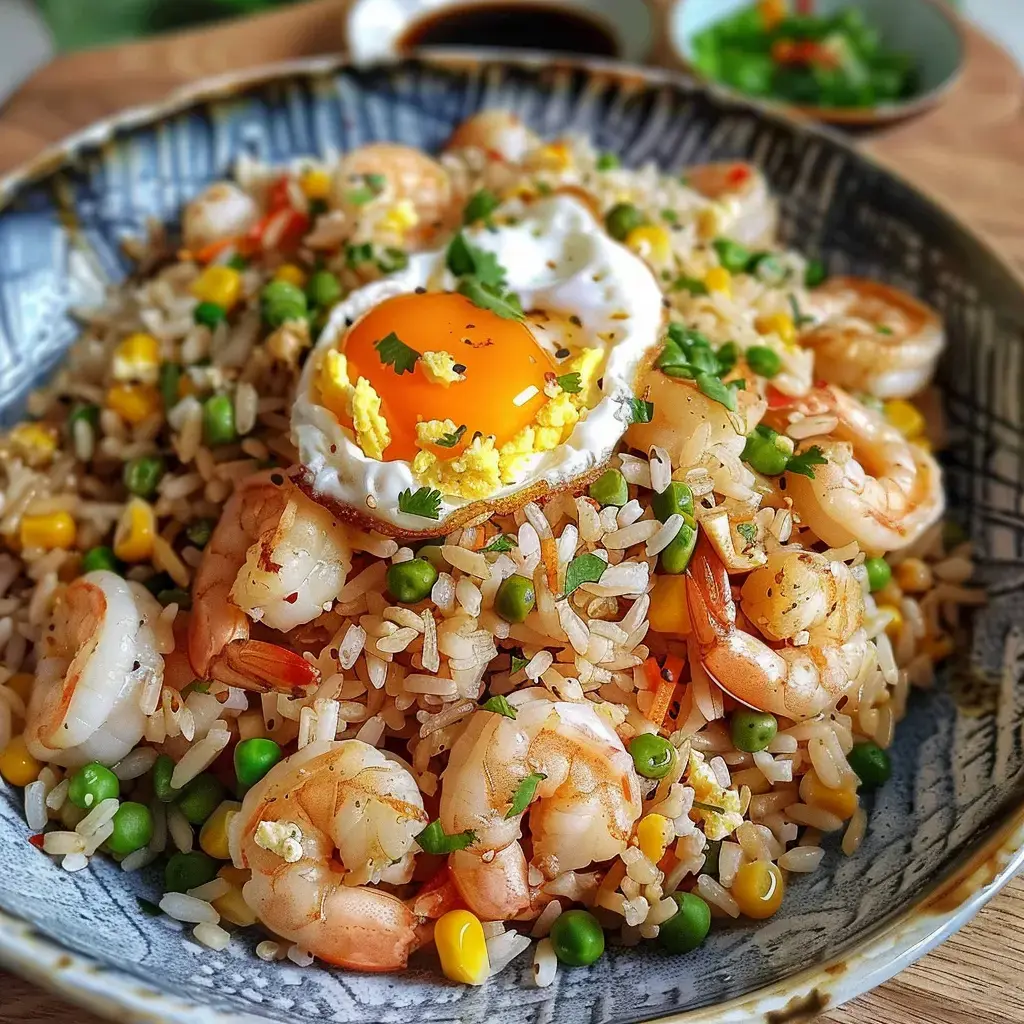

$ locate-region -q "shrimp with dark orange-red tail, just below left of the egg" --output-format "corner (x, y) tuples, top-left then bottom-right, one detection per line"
(188, 472), (352, 695)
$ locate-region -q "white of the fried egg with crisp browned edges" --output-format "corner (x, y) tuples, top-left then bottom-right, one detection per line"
(292, 196), (663, 532)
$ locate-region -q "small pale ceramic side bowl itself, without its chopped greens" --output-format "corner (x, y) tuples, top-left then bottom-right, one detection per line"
(667, 0), (965, 127)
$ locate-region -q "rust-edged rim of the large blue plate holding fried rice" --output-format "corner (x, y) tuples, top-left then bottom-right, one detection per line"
(0, 48), (1024, 1024)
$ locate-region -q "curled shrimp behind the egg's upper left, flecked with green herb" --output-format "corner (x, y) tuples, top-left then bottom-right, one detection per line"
(333, 142), (460, 244)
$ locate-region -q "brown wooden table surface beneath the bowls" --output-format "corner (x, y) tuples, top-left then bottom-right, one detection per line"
(0, 0), (1024, 1024)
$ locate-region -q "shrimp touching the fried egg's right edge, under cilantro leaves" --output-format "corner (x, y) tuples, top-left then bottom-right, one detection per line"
(626, 369), (767, 466)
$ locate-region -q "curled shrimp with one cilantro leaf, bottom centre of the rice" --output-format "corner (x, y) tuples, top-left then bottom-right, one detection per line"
(440, 699), (640, 921)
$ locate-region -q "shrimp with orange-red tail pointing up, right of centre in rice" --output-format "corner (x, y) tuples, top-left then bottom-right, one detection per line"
(686, 537), (868, 721)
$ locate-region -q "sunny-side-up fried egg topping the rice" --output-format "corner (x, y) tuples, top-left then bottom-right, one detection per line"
(292, 195), (663, 535)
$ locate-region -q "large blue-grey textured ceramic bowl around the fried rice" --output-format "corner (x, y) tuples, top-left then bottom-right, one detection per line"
(0, 56), (1024, 1024)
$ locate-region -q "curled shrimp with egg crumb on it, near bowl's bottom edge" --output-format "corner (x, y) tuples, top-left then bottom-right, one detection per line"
(229, 739), (430, 971)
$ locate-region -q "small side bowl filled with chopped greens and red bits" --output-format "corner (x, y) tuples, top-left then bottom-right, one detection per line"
(669, 0), (965, 125)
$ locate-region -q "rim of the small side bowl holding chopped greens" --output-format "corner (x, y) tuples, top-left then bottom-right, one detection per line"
(665, 0), (967, 128)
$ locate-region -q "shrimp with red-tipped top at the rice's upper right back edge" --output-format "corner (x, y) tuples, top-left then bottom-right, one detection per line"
(684, 163), (778, 247)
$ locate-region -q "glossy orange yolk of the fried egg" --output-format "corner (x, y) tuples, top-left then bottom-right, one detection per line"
(342, 292), (557, 462)
